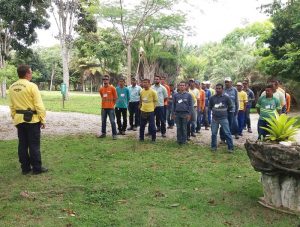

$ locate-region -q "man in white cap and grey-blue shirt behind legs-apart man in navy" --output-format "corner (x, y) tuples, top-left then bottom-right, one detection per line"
(220, 77), (239, 142)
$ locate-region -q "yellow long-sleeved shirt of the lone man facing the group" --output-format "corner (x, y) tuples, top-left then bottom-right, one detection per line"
(9, 79), (46, 125)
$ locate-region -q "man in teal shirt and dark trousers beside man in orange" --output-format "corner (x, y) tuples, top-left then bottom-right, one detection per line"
(115, 78), (130, 135)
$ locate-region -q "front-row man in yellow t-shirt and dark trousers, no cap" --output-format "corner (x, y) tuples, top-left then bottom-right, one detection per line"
(140, 79), (158, 142)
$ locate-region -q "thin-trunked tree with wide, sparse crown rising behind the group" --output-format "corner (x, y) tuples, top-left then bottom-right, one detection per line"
(100, 0), (184, 82)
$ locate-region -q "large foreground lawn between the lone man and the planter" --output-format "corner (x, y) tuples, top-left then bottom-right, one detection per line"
(0, 135), (299, 226)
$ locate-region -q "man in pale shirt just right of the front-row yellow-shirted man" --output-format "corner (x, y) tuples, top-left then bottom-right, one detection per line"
(151, 75), (168, 137)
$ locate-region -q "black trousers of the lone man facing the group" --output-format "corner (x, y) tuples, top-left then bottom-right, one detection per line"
(17, 123), (42, 172)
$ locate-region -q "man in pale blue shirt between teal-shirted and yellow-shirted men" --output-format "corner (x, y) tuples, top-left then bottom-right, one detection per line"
(128, 77), (142, 131)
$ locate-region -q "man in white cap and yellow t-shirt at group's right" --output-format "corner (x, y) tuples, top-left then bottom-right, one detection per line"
(236, 82), (248, 136)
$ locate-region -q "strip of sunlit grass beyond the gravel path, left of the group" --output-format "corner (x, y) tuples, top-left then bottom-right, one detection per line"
(0, 91), (101, 114)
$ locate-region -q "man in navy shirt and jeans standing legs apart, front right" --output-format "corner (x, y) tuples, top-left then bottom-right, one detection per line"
(209, 84), (233, 153)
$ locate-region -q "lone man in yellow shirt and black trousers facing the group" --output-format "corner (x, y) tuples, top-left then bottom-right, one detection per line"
(9, 65), (48, 175)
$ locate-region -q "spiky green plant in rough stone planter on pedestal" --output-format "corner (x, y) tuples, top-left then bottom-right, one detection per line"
(245, 113), (300, 214)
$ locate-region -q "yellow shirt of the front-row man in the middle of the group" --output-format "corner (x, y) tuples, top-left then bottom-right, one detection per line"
(141, 88), (158, 112)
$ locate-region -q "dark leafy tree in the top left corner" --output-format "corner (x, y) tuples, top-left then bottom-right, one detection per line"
(0, 0), (50, 97)
